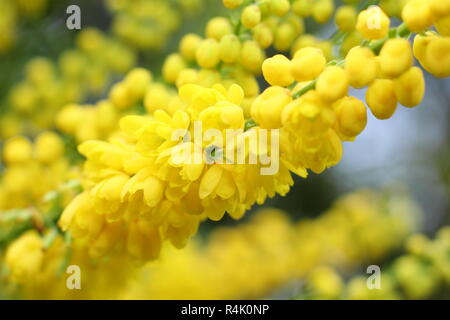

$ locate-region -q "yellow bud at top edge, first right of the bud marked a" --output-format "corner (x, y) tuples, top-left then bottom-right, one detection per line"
(402, 0), (434, 32)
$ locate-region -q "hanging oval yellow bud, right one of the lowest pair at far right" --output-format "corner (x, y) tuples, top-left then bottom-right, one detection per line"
(394, 67), (425, 108)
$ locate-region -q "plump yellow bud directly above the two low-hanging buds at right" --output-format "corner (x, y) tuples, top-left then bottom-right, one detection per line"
(379, 38), (413, 78)
